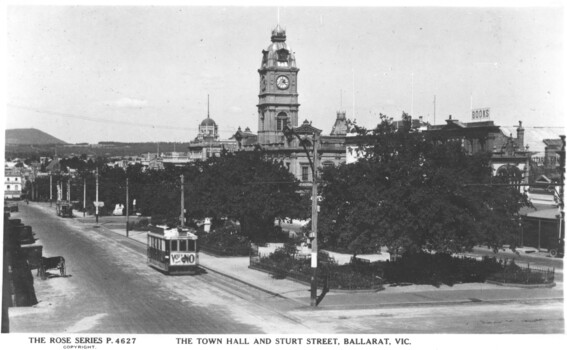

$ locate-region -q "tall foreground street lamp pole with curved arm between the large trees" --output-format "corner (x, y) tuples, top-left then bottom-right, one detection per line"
(282, 120), (320, 307)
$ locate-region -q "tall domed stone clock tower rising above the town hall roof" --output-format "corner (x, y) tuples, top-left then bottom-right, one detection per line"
(257, 24), (299, 146)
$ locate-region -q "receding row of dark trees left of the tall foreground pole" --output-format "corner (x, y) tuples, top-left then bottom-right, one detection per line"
(28, 151), (308, 241)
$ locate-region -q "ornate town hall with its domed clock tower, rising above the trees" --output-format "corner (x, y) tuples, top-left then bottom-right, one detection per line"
(247, 24), (347, 185)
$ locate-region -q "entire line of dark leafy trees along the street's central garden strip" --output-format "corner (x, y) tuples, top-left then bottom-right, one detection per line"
(25, 115), (529, 253)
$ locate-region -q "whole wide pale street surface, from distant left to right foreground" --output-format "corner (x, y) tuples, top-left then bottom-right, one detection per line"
(5, 202), (565, 334)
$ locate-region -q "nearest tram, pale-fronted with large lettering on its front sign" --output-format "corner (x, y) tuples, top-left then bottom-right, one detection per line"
(147, 225), (199, 275)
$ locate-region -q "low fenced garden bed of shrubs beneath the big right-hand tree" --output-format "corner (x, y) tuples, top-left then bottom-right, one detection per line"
(250, 249), (555, 290)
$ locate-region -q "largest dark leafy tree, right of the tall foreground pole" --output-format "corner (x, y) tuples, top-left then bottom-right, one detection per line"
(320, 114), (528, 253)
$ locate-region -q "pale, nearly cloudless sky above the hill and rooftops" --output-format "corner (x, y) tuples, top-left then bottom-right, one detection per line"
(5, 5), (565, 143)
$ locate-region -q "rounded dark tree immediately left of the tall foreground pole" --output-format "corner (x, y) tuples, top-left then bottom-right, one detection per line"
(185, 151), (307, 242)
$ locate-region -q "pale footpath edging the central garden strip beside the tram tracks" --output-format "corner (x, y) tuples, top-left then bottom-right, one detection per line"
(75, 214), (563, 310)
